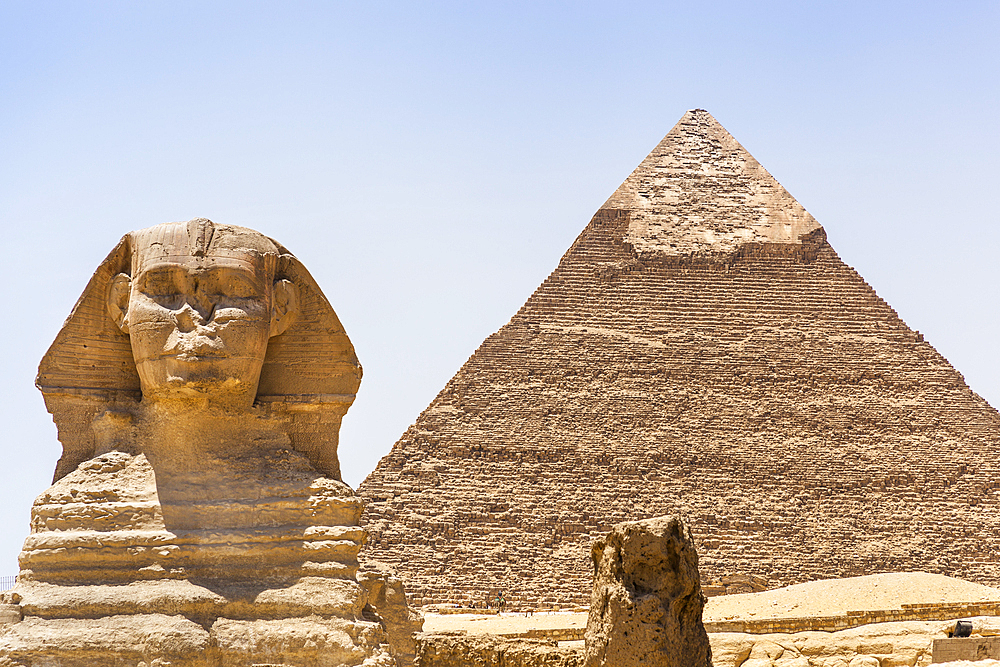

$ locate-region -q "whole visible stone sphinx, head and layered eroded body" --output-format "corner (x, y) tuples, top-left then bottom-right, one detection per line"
(0, 219), (412, 667)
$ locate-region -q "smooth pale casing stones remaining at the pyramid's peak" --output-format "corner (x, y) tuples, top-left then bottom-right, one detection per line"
(602, 109), (821, 256)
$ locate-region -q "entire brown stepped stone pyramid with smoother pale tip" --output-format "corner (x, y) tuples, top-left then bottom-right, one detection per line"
(359, 110), (1000, 604)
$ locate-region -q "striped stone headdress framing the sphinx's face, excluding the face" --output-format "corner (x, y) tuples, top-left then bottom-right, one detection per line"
(35, 218), (362, 480)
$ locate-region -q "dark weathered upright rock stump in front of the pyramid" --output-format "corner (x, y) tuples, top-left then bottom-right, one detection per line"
(584, 517), (716, 667)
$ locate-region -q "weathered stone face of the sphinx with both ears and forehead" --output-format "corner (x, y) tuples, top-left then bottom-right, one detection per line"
(107, 219), (299, 408)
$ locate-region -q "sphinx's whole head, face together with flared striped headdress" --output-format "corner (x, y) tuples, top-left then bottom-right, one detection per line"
(35, 219), (361, 479)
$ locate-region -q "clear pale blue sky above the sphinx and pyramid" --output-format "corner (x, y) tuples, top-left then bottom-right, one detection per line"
(0, 0), (1000, 574)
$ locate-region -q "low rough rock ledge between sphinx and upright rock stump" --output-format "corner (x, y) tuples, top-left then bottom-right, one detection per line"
(414, 634), (582, 667)
